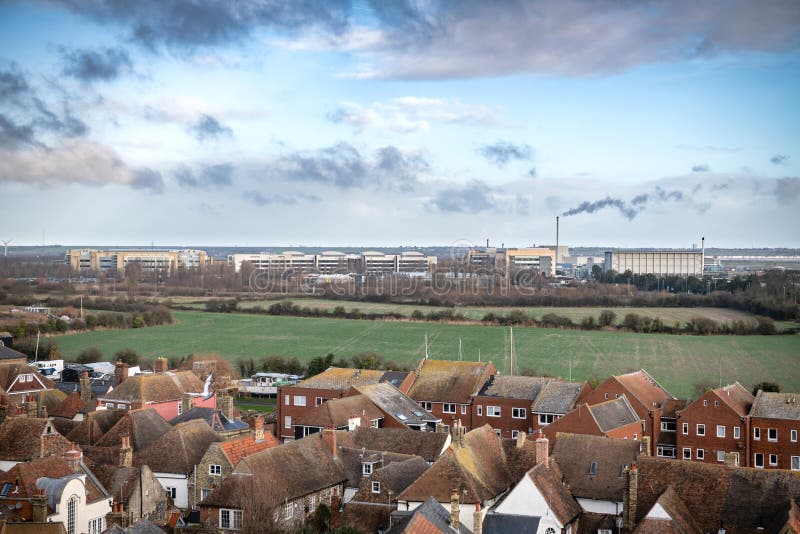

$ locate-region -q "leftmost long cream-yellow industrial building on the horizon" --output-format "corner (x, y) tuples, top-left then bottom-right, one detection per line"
(64, 249), (211, 273)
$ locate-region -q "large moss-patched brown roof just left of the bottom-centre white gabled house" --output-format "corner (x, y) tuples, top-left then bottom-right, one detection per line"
(398, 425), (530, 503)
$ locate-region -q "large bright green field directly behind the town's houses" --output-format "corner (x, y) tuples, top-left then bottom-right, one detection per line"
(54, 312), (800, 396)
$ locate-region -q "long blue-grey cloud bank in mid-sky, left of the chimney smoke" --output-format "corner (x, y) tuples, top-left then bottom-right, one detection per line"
(267, 143), (430, 191)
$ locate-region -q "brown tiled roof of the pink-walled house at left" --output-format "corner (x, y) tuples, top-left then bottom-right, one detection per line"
(99, 371), (205, 404)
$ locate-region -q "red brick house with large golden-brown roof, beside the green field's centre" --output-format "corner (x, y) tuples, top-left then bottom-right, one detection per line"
(408, 359), (497, 431)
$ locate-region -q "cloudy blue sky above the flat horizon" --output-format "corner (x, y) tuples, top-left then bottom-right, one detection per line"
(0, 0), (800, 247)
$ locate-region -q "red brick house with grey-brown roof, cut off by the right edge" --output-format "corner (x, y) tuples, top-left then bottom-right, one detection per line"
(748, 390), (800, 471)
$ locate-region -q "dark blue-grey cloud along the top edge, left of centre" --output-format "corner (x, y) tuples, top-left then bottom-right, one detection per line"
(50, 0), (349, 51)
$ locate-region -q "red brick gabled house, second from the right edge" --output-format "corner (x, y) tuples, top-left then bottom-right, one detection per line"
(672, 382), (753, 464)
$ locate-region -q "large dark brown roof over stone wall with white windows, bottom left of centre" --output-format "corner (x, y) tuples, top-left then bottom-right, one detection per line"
(202, 432), (346, 507)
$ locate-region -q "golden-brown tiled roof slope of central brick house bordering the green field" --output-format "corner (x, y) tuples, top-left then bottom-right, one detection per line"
(408, 360), (492, 404)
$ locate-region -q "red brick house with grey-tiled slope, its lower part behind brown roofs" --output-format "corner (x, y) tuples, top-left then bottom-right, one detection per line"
(542, 394), (643, 447)
